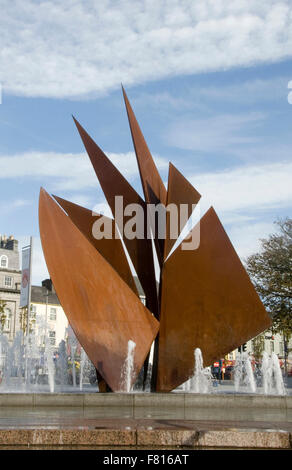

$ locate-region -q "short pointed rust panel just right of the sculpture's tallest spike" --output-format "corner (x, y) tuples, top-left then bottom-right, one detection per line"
(164, 163), (201, 259)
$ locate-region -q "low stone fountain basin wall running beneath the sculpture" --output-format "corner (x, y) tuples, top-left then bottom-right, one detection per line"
(0, 393), (292, 449)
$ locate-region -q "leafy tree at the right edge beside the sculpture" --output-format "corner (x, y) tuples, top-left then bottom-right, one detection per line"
(246, 218), (292, 372)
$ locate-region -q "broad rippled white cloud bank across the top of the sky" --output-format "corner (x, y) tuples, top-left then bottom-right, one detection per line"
(0, 0), (292, 98)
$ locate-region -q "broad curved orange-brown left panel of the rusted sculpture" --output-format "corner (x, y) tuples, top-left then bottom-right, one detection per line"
(39, 189), (159, 391)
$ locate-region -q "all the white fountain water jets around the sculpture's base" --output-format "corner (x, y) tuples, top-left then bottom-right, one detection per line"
(0, 330), (287, 395)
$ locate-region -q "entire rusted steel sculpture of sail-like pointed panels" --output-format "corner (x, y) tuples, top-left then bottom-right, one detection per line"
(39, 89), (271, 392)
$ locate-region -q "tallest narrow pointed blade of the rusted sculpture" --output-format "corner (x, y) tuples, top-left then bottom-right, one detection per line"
(122, 87), (167, 266)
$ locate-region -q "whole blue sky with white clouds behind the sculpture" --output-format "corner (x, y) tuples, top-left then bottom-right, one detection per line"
(0, 0), (292, 283)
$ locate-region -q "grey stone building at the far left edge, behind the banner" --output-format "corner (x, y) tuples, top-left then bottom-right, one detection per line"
(0, 235), (21, 343)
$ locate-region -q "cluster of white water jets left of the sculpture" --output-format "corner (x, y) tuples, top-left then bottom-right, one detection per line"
(0, 330), (96, 393)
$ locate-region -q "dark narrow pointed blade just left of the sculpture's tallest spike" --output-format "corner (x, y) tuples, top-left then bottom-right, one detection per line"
(74, 119), (158, 317)
